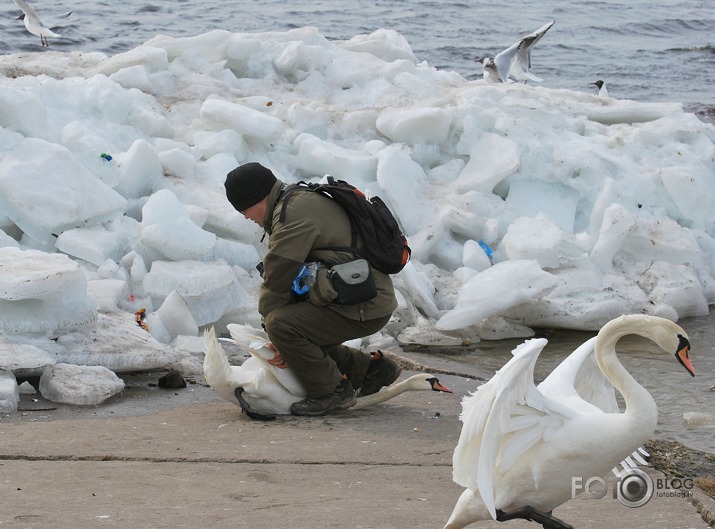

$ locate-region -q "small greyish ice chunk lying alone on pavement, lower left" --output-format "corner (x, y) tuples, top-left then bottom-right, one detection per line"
(40, 364), (124, 406)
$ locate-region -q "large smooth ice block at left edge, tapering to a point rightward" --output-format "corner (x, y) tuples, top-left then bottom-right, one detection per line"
(0, 138), (127, 243)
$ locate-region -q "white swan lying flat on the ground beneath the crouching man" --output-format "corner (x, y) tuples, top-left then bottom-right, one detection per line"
(204, 324), (451, 420)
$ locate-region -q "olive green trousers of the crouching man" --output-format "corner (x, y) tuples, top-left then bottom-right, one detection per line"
(263, 301), (390, 398)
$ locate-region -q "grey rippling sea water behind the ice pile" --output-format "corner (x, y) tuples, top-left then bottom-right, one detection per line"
(0, 0), (715, 122)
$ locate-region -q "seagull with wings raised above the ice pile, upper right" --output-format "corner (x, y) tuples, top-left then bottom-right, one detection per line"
(480, 20), (555, 83)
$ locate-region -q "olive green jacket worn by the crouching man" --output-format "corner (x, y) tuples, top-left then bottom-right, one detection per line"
(258, 180), (397, 321)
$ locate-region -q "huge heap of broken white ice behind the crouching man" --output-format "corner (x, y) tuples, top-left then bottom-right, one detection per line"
(0, 27), (715, 407)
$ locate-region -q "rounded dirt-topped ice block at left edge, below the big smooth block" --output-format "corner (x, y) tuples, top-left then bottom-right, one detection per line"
(0, 247), (97, 333)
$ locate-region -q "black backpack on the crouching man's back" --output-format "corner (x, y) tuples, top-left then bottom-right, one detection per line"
(279, 176), (412, 274)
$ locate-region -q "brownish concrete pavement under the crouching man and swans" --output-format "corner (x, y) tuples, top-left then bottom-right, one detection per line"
(0, 373), (715, 529)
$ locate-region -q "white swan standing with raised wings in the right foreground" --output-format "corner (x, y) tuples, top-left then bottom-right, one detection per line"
(445, 315), (695, 529)
